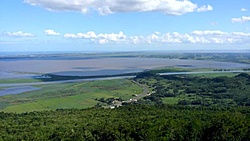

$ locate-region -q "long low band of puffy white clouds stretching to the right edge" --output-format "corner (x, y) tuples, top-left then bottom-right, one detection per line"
(64, 30), (250, 44)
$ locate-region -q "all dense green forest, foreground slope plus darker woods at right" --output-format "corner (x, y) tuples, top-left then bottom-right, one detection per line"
(0, 71), (250, 141)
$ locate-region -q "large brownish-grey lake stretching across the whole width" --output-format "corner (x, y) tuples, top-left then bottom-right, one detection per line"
(0, 57), (250, 79)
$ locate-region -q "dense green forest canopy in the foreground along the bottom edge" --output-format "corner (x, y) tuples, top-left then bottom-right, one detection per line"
(0, 104), (250, 141)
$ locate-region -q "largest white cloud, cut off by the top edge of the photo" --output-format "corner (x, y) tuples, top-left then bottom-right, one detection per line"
(24, 0), (213, 15)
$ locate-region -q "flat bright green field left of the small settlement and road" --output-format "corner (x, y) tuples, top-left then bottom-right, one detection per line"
(0, 79), (142, 113)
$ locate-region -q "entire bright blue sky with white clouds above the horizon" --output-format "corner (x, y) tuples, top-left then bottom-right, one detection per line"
(0, 0), (250, 52)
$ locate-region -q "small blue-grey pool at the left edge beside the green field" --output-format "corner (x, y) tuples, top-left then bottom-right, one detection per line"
(0, 86), (40, 96)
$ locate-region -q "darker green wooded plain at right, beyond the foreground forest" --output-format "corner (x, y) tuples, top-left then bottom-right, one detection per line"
(136, 72), (250, 107)
